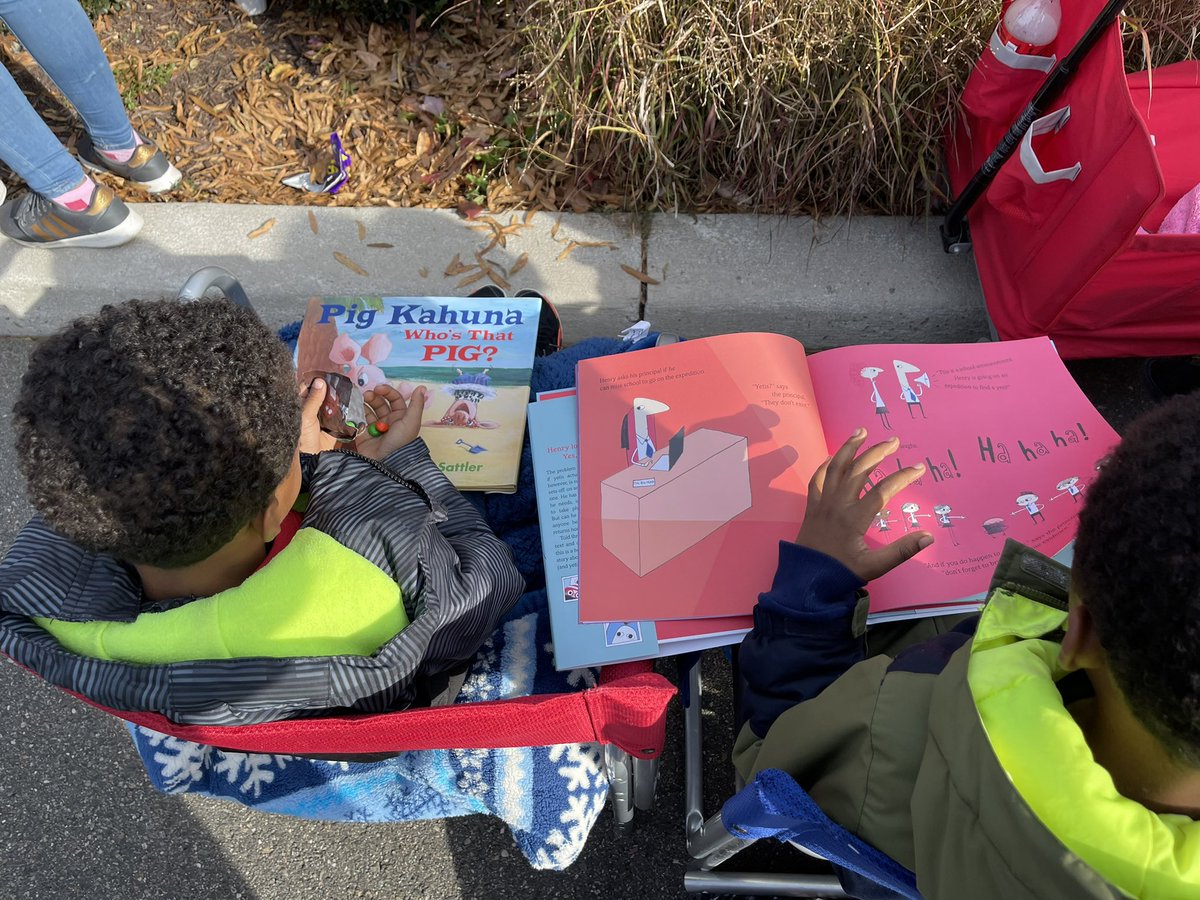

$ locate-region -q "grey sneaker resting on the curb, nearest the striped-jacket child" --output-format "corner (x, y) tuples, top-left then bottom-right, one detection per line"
(0, 185), (142, 247)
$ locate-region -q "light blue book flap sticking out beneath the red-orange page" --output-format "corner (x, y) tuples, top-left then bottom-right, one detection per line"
(528, 391), (659, 671)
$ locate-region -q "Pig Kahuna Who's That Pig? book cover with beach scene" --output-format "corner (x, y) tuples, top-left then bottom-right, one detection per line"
(295, 296), (540, 492)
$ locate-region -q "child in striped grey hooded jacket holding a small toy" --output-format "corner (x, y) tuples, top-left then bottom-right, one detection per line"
(0, 300), (524, 725)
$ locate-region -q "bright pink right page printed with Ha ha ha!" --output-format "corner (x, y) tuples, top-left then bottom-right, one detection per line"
(809, 337), (1118, 613)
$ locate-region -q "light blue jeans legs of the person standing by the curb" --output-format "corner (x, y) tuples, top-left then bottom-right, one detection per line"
(0, 0), (134, 197)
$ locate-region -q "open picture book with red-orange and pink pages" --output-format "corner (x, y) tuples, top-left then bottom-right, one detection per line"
(577, 334), (1117, 623)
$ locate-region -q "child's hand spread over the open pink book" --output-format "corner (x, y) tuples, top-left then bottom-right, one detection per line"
(796, 428), (934, 581)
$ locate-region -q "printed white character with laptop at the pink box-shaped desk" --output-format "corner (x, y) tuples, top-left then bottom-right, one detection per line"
(600, 397), (751, 575)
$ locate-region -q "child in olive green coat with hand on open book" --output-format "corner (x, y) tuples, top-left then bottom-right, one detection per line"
(733, 396), (1200, 900)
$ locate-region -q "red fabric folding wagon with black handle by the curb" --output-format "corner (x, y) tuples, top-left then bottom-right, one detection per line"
(943, 0), (1200, 358)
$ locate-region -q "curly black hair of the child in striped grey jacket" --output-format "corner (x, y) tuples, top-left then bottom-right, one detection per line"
(13, 300), (300, 568)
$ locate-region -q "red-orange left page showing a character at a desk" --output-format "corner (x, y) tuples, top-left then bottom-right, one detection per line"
(577, 334), (826, 622)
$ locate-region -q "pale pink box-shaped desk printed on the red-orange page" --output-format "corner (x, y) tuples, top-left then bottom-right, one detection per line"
(600, 428), (750, 576)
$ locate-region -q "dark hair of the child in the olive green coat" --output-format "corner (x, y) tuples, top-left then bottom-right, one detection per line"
(1072, 395), (1200, 764)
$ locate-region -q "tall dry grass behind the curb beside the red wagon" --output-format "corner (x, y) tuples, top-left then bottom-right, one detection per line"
(524, 0), (1200, 214)
